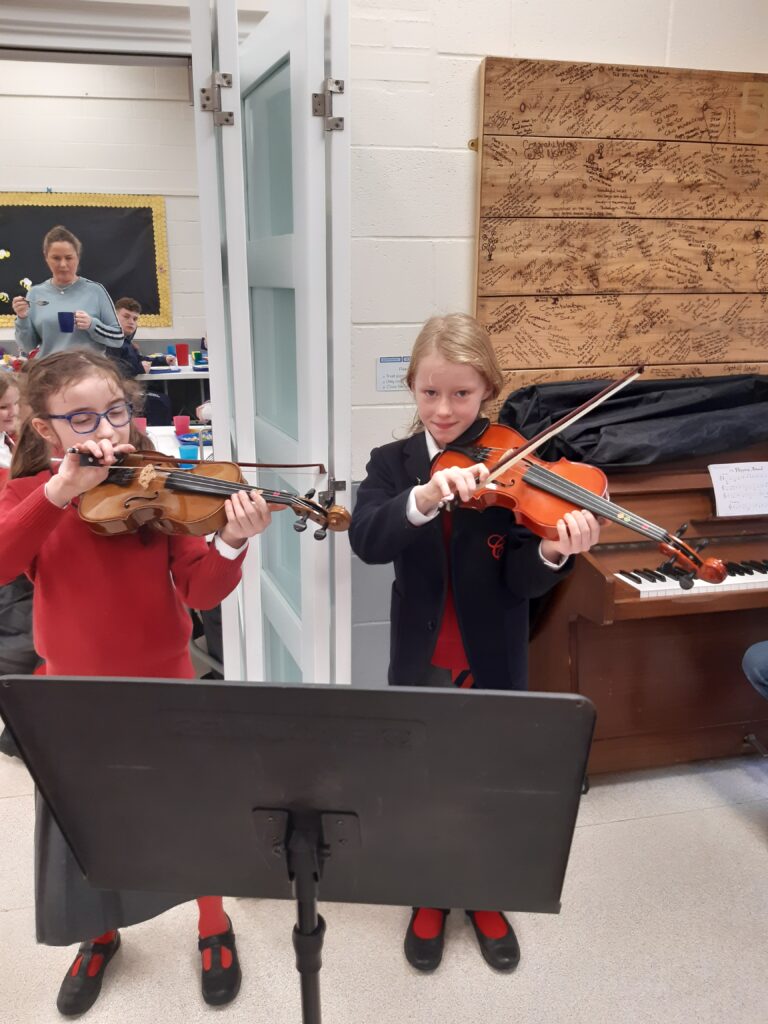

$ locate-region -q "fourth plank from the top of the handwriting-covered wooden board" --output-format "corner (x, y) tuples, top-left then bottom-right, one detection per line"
(477, 295), (768, 370)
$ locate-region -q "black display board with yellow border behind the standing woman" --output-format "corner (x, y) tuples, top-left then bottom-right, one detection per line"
(0, 193), (173, 327)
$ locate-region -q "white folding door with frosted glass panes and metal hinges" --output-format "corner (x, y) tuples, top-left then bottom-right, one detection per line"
(190, 0), (350, 683)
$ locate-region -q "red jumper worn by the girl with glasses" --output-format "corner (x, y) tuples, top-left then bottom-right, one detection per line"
(0, 470), (245, 679)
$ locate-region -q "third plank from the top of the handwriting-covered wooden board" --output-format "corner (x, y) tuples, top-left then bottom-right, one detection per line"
(478, 217), (768, 296)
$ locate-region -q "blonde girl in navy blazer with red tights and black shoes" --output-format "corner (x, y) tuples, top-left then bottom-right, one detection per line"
(349, 313), (600, 971)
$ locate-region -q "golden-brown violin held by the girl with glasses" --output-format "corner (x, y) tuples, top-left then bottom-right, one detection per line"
(78, 452), (351, 541)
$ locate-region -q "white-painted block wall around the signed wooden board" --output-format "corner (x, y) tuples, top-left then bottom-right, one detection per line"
(350, 0), (768, 479)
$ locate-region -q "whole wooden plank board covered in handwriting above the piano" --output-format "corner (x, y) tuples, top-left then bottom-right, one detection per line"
(475, 57), (768, 405)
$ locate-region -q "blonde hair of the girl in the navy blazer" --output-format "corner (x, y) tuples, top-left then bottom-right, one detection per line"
(406, 313), (504, 434)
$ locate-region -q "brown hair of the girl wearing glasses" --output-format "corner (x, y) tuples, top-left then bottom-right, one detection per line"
(10, 348), (153, 478)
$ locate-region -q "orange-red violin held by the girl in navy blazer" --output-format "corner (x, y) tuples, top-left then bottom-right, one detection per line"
(431, 420), (728, 590)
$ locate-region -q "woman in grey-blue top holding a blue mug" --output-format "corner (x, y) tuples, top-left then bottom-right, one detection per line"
(12, 224), (123, 355)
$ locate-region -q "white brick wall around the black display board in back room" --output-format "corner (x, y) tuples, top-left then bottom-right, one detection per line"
(0, 60), (206, 342)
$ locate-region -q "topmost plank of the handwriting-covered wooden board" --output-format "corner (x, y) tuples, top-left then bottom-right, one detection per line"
(485, 57), (768, 145)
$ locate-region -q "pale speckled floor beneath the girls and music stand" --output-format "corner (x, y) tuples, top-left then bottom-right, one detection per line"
(0, 757), (768, 1024)
